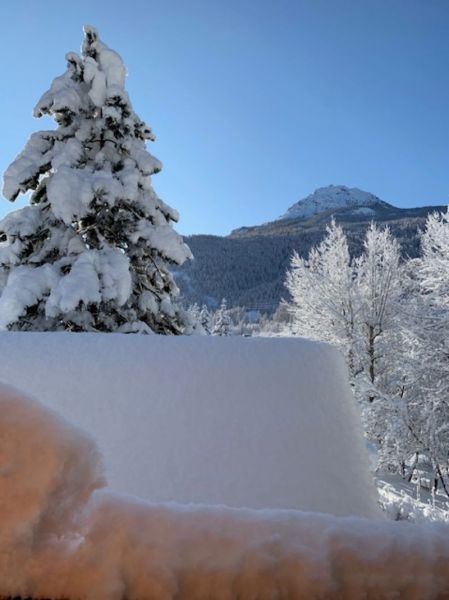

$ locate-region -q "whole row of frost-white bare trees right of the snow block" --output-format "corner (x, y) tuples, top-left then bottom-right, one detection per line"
(286, 213), (449, 495)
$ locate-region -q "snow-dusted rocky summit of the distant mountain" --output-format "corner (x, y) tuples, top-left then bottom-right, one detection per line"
(279, 185), (389, 219)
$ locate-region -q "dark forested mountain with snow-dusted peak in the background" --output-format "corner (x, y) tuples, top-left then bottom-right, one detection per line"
(175, 186), (446, 313)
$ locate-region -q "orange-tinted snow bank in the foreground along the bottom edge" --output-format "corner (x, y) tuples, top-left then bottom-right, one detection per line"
(0, 386), (449, 600)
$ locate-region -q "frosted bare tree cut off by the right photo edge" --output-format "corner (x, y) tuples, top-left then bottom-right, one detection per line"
(404, 212), (449, 495)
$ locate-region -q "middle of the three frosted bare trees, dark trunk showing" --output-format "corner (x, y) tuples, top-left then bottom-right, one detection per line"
(354, 224), (413, 473)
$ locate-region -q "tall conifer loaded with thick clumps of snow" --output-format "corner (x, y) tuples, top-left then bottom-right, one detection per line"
(0, 27), (191, 334)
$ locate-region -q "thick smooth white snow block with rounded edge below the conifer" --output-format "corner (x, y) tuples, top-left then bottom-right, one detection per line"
(0, 332), (379, 516)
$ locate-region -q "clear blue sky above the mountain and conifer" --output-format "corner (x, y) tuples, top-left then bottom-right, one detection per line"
(0, 0), (449, 234)
